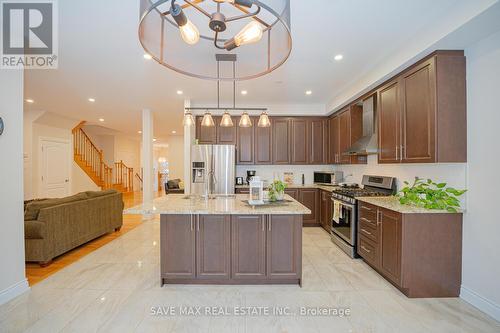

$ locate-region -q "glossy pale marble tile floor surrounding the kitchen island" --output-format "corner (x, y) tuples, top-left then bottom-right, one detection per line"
(0, 220), (500, 333)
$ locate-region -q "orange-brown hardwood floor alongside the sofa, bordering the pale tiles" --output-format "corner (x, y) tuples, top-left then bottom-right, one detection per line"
(26, 192), (163, 286)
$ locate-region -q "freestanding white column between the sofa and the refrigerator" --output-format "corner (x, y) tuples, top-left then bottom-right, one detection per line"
(142, 109), (154, 202)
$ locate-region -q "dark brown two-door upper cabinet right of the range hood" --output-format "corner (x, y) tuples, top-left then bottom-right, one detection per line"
(377, 51), (467, 163)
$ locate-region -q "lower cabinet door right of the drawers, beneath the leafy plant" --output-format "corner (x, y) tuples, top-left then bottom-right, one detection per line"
(379, 208), (401, 284)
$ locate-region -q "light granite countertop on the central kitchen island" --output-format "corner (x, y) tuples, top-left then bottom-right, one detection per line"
(123, 194), (311, 215)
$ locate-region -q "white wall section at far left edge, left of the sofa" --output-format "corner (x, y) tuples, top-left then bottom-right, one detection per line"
(0, 70), (29, 304)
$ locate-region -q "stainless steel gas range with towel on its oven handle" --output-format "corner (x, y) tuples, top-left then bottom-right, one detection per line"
(331, 175), (396, 258)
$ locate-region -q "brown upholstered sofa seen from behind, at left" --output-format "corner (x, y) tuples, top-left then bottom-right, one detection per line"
(24, 190), (124, 265)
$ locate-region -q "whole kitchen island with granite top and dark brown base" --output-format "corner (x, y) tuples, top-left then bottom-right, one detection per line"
(124, 194), (311, 285)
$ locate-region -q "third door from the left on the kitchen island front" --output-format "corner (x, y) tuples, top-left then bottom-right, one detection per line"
(231, 215), (267, 280)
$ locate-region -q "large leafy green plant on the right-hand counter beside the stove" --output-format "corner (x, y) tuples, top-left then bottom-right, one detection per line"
(398, 177), (467, 213)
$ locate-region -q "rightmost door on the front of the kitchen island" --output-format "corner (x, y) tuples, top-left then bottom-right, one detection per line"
(267, 215), (302, 279)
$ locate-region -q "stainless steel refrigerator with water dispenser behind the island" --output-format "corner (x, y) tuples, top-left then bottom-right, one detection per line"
(191, 145), (236, 196)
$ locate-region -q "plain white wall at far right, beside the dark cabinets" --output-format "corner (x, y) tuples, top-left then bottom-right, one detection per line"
(461, 32), (500, 320)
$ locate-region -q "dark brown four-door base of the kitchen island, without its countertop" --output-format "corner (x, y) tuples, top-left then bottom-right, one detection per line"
(160, 215), (302, 284)
